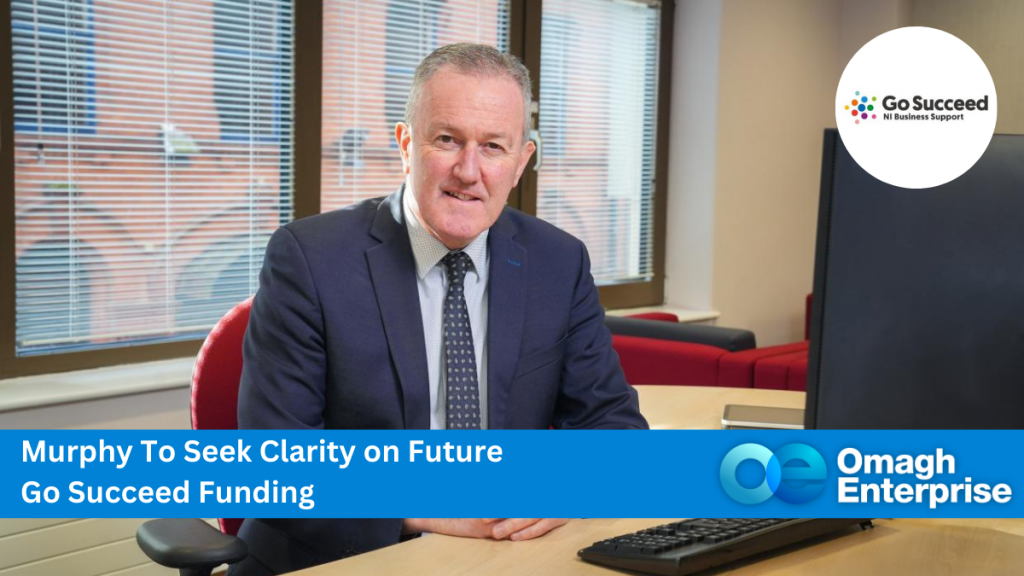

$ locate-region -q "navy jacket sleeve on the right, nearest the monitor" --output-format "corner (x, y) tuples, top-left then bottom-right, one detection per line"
(554, 243), (648, 429)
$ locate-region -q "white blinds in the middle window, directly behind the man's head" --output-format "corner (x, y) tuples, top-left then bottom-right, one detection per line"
(321, 0), (509, 211)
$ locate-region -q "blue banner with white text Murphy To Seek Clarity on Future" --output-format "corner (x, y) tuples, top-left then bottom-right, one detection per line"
(0, 430), (1024, 518)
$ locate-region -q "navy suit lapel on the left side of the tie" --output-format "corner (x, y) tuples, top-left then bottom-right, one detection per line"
(367, 190), (430, 429)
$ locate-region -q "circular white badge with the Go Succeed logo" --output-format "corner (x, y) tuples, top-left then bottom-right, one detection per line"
(836, 28), (995, 189)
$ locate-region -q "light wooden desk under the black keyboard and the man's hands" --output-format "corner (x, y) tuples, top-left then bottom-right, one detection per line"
(296, 386), (1024, 576)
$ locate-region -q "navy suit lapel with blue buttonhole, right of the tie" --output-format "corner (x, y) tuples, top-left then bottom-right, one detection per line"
(487, 212), (527, 429)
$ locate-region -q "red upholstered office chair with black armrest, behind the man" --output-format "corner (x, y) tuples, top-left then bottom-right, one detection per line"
(135, 298), (252, 576)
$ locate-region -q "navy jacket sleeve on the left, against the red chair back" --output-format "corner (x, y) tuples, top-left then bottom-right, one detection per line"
(232, 228), (402, 576)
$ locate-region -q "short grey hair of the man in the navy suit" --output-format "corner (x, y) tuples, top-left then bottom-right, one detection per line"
(406, 43), (532, 142)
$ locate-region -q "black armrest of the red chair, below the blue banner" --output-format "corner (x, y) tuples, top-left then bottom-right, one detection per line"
(135, 518), (249, 573)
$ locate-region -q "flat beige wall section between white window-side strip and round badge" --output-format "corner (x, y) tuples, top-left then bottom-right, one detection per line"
(712, 0), (841, 345)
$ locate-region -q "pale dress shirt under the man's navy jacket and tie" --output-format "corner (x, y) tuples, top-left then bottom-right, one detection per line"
(401, 188), (490, 430)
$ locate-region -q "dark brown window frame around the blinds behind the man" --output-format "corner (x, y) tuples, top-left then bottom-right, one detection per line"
(0, 0), (674, 378)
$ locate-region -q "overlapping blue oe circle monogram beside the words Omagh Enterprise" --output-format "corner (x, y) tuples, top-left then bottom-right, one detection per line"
(719, 444), (828, 504)
